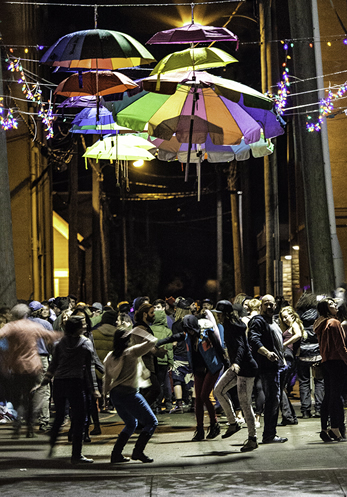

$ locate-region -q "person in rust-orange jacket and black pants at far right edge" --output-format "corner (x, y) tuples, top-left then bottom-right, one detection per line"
(313, 297), (347, 442)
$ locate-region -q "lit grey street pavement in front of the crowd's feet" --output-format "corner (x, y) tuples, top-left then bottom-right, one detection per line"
(0, 401), (347, 497)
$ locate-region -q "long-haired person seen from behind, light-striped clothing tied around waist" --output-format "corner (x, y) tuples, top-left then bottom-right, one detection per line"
(295, 293), (324, 419)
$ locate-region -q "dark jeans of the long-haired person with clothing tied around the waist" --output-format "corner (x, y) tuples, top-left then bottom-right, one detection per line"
(297, 359), (324, 413)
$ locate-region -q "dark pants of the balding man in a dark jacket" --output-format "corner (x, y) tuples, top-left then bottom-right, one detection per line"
(260, 370), (281, 440)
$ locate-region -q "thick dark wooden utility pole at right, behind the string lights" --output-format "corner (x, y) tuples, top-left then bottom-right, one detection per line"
(288, 0), (335, 293)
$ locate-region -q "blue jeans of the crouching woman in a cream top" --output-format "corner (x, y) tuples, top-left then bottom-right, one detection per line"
(110, 387), (158, 437)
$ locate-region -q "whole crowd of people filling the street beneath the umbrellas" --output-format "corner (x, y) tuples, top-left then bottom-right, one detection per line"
(0, 293), (347, 464)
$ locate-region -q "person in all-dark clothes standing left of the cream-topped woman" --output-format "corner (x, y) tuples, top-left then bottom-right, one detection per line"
(42, 316), (100, 464)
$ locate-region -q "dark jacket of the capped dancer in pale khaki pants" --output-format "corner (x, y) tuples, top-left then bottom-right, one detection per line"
(224, 317), (258, 378)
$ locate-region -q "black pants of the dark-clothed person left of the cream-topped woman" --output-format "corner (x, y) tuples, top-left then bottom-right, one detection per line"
(50, 378), (87, 458)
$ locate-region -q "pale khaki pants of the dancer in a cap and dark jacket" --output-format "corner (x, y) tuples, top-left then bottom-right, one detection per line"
(214, 368), (256, 437)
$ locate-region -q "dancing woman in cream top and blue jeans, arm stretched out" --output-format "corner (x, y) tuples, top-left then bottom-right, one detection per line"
(104, 320), (179, 463)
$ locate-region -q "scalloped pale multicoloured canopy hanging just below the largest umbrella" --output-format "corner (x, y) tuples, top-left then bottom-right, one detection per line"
(148, 136), (274, 164)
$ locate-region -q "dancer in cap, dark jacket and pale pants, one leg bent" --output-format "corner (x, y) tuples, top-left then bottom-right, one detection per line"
(214, 300), (258, 452)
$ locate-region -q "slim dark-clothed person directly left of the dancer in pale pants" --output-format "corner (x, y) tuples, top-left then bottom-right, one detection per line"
(182, 314), (224, 442)
